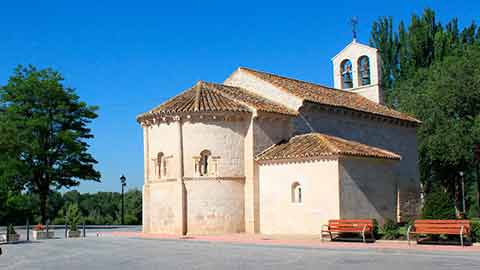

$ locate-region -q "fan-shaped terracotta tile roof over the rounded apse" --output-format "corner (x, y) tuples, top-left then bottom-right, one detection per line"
(137, 81), (296, 121)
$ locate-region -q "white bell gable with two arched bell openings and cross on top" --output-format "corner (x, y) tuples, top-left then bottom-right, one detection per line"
(332, 19), (383, 104)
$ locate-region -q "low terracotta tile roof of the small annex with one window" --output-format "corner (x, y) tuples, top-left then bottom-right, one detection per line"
(256, 133), (401, 161)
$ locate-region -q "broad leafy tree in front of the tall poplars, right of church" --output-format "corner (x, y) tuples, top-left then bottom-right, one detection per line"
(396, 47), (480, 215)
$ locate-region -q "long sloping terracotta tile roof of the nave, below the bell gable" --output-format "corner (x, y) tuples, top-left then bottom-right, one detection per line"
(239, 67), (421, 123)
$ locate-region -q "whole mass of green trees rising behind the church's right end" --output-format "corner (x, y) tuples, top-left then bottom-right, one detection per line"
(370, 9), (480, 215)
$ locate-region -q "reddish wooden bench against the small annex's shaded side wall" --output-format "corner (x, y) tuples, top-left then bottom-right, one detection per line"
(321, 219), (375, 243)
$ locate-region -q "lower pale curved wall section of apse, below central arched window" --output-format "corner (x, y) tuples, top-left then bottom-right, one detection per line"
(185, 180), (245, 234)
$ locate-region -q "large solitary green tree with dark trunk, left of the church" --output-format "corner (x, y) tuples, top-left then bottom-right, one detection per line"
(0, 66), (100, 223)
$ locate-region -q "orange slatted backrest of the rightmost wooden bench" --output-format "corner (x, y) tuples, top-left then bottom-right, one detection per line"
(414, 219), (470, 234)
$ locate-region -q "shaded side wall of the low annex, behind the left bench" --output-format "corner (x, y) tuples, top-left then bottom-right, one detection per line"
(340, 157), (397, 223)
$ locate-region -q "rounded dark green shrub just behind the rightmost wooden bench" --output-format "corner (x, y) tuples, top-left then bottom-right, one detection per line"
(422, 190), (456, 219)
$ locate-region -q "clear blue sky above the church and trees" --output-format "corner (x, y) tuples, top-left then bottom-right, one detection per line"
(0, 0), (480, 192)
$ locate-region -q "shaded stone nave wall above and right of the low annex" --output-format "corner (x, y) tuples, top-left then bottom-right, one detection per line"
(294, 102), (420, 220)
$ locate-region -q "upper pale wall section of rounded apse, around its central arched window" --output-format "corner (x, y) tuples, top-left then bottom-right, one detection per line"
(183, 117), (248, 177)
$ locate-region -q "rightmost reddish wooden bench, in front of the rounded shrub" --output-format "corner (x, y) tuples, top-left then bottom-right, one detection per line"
(407, 219), (470, 246)
